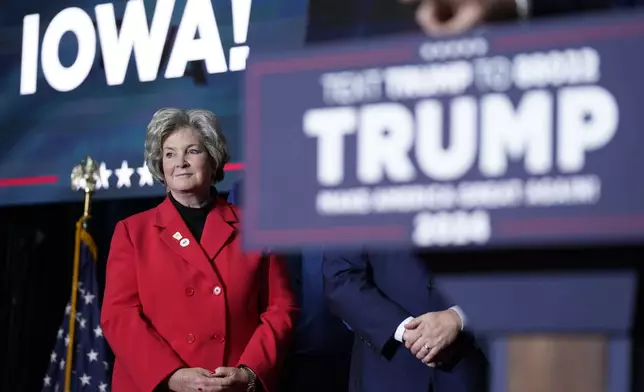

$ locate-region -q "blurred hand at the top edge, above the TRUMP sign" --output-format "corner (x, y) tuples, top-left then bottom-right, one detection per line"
(399, 0), (518, 36)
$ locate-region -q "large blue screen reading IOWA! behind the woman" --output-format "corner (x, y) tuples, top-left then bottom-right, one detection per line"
(0, 0), (308, 205)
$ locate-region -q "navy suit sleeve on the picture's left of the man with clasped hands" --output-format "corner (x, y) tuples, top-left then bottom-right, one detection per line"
(323, 253), (412, 355)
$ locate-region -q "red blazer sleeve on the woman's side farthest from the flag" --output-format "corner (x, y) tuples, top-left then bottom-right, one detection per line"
(237, 255), (299, 392)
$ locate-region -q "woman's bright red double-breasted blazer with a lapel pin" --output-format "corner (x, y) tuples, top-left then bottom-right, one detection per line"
(101, 198), (298, 392)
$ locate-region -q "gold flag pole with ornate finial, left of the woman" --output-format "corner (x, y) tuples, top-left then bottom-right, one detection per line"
(64, 156), (98, 392)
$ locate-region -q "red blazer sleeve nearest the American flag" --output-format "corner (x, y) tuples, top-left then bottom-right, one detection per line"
(101, 221), (186, 392)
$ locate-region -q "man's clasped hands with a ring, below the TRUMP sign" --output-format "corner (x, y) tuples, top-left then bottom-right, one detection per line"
(403, 309), (461, 366)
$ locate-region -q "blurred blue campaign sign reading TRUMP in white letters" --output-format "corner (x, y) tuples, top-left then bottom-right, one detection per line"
(244, 13), (644, 253)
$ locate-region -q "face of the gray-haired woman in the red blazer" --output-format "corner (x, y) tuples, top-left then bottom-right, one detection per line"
(163, 128), (213, 193)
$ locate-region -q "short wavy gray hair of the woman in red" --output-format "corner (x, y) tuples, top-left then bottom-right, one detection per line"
(145, 108), (230, 184)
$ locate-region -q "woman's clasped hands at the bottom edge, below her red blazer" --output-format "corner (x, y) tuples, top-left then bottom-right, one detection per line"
(168, 367), (249, 392)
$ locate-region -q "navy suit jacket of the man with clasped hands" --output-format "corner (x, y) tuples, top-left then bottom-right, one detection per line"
(323, 251), (487, 392)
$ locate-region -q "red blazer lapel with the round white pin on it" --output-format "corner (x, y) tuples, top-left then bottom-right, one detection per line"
(157, 197), (216, 277)
